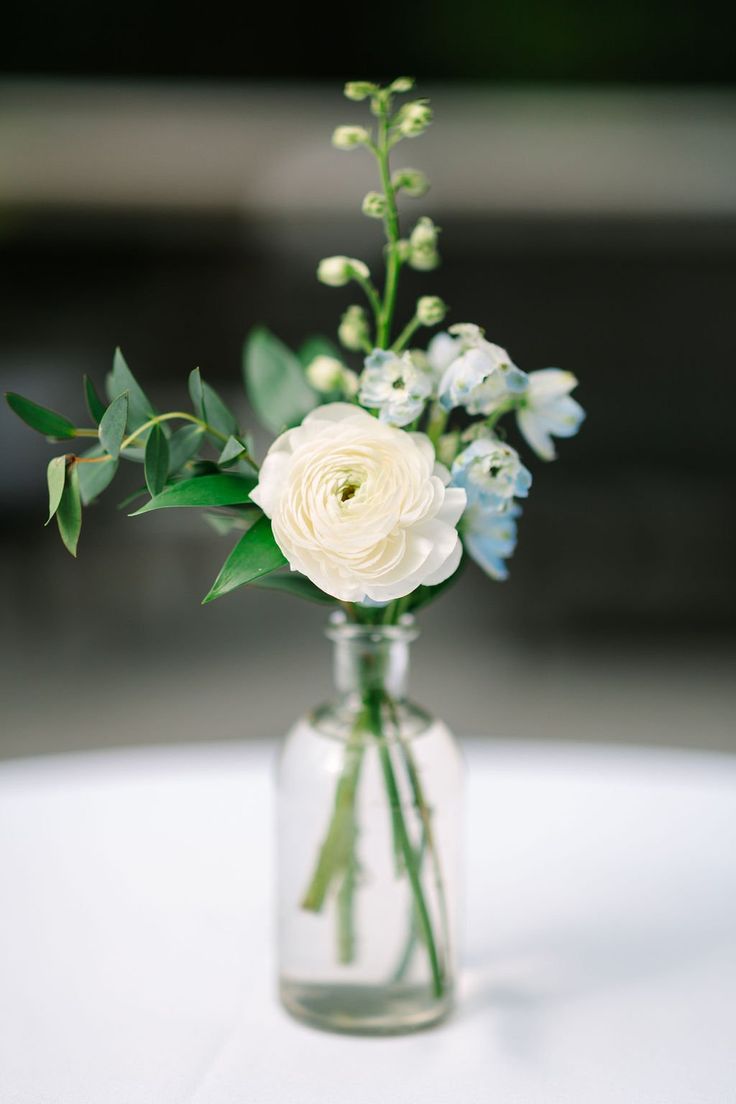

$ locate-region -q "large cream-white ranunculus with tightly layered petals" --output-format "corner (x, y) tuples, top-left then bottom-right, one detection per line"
(250, 403), (466, 602)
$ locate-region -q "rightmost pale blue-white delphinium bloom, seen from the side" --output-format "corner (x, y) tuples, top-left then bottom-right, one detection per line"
(516, 368), (585, 460)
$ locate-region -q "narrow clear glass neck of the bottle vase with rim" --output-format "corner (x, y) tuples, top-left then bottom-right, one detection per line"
(327, 615), (417, 700)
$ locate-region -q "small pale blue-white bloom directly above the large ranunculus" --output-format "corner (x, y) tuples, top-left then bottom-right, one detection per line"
(358, 349), (433, 426)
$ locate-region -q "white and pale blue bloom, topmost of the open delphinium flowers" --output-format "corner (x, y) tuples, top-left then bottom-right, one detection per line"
(439, 322), (529, 416)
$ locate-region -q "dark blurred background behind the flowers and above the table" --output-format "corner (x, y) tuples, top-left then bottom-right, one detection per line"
(0, 0), (736, 757)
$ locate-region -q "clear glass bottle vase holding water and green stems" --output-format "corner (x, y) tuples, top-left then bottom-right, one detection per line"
(278, 614), (462, 1034)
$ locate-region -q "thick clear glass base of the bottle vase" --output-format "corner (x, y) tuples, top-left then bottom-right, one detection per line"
(279, 978), (452, 1036)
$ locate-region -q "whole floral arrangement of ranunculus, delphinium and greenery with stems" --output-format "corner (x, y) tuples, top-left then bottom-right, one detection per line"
(7, 77), (584, 1011)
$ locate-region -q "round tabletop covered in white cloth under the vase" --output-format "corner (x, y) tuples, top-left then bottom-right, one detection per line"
(0, 741), (736, 1104)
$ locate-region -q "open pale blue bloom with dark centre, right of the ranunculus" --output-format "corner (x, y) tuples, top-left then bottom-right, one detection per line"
(452, 436), (532, 511)
